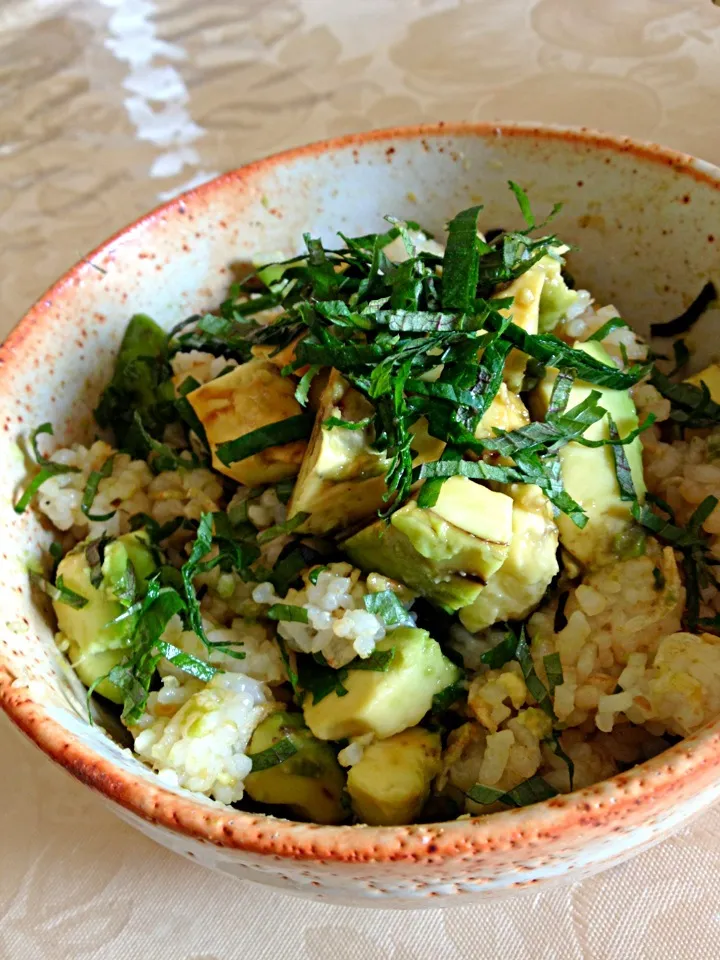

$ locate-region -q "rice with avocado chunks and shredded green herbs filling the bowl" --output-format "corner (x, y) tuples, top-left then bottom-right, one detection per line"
(16, 184), (720, 824)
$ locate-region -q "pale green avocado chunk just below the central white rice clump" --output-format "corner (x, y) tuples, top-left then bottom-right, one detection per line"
(303, 627), (460, 740)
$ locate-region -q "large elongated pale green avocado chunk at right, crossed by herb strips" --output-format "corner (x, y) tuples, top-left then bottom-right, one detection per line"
(531, 341), (646, 567)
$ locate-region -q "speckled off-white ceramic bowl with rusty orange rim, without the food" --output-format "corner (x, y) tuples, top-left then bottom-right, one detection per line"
(0, 124), (720, 906)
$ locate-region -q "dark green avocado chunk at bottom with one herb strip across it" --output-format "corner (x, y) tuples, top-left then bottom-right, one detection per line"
(245, 710), (347, 823)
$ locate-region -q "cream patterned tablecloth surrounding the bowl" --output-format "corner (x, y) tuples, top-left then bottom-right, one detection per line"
(0, 0), (720, 960)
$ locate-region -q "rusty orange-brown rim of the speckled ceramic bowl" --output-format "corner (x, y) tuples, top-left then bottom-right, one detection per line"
(0, 121), (720, 863)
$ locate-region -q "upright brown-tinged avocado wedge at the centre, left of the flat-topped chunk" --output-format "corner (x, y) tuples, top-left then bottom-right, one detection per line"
(288, 370), (388, 535)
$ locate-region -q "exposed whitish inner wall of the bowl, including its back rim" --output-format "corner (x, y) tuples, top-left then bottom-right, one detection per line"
(0, 126), (720, 832)
